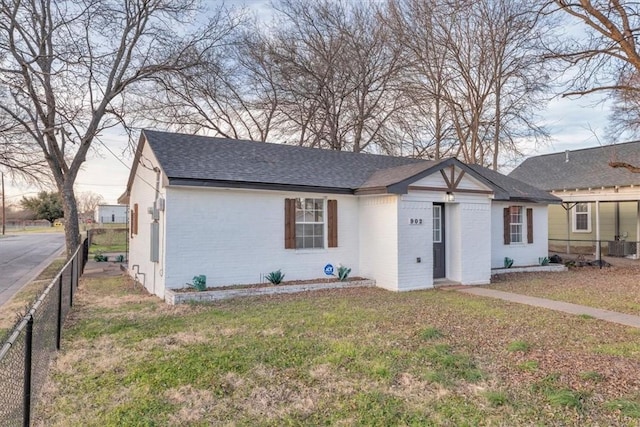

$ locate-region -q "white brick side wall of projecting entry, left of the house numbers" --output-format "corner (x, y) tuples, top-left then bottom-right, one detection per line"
(359, 196), (398, 290)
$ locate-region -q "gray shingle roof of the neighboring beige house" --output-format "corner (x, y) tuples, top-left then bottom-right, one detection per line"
(509, 141), (640, 191)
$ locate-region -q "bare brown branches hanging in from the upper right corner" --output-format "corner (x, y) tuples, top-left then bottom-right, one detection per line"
(542, 0), (640, 143)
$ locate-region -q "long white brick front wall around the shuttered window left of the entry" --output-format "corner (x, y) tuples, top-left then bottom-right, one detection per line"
(166, 187), (361, 288)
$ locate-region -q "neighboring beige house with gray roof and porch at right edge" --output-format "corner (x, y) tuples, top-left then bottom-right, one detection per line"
(509, 141), (640, 257)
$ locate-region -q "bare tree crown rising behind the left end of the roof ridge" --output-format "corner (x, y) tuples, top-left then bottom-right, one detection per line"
(138, 13), (277, 141)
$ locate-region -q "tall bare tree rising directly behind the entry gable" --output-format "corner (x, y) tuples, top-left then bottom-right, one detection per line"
(388, 0), (546, 169)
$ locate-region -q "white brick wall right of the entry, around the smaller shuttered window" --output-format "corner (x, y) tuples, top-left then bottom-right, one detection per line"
(491, 202), (549, 268)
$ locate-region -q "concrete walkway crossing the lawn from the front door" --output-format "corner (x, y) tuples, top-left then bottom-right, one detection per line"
(455, 286), (640, 328)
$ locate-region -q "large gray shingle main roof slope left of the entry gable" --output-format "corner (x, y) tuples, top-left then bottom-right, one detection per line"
(143, 130), (423, 190)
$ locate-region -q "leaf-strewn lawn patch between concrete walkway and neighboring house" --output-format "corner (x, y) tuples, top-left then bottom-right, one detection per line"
(490, 261), (640, 316)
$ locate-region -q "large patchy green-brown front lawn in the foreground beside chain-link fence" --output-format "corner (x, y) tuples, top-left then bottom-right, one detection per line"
(36, 277), (640, 426)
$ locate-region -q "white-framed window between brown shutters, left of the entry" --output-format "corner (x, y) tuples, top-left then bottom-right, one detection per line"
(296, 198), (324, 249)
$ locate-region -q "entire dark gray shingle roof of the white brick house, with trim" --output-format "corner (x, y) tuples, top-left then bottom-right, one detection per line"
(120, 130), (560, 203)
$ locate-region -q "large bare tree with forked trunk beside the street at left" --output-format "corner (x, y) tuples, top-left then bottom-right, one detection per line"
(0, 0), (234, 253)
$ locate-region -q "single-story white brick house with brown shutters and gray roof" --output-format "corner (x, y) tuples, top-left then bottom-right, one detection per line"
(120, 131), (559, 297)
